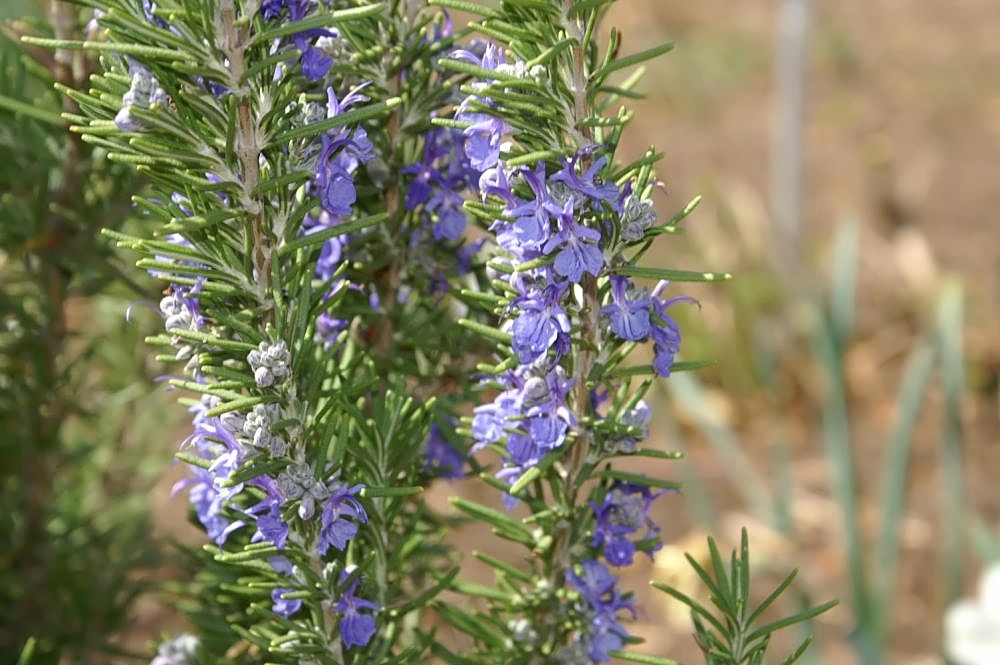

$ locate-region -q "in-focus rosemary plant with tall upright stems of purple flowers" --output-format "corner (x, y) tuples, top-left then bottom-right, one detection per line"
(19, 0), (836, 665)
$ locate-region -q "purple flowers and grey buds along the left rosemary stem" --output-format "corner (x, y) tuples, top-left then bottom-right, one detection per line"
(161, 80), (378, 646)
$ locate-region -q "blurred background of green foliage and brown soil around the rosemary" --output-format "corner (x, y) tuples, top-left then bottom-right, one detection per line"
(0, 0), (1000, 665)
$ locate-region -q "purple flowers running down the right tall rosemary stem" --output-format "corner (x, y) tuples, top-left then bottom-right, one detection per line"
(456, 39), (691, 662)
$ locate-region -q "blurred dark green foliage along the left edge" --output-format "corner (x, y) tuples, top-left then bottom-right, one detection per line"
(0, 5), (170, 662)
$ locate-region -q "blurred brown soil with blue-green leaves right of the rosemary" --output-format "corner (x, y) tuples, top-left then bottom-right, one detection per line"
(611, 0), (1000, 664)
